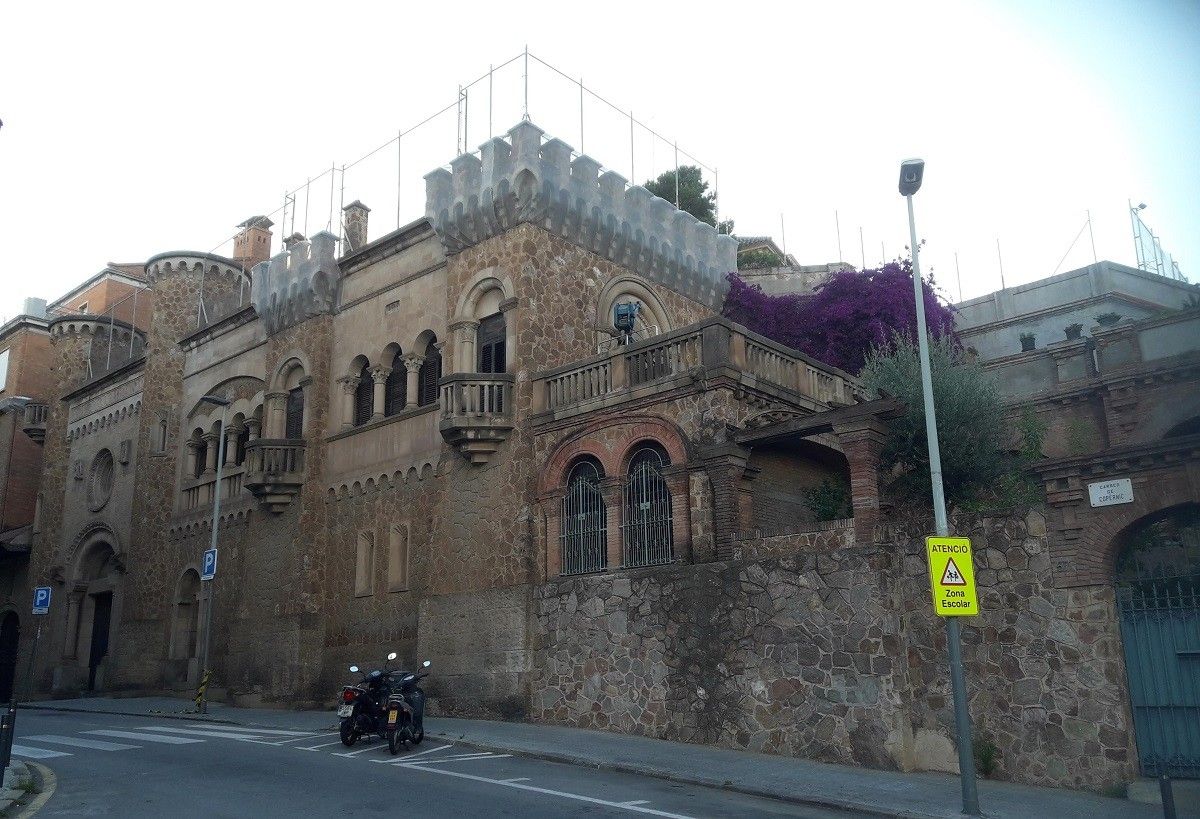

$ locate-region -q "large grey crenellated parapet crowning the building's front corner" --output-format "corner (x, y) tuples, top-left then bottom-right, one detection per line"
(425, 121), (738, 309)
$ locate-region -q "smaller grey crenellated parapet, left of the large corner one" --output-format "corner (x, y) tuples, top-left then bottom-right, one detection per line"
(251, 231), (342, 334)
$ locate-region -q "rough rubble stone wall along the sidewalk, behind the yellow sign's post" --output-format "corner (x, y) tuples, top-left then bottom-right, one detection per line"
(530, 512), (1136, 789)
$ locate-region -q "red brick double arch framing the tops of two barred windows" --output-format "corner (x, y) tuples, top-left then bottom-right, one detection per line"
(538, 416), (690, 492)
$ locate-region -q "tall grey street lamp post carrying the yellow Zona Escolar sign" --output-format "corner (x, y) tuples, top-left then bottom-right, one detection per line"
(900, 160), (979, 815)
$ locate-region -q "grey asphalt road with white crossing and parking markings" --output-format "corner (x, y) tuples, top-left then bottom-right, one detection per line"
(13, 711), (852, 819)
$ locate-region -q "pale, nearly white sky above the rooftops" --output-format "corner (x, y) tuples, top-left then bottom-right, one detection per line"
(0, 0), (1200, 317)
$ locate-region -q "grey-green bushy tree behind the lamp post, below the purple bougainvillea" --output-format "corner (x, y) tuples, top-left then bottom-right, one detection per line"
(860, 336), (1015, 506)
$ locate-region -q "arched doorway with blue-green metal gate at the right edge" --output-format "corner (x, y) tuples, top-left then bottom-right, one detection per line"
(1116, 504), (1200, 777)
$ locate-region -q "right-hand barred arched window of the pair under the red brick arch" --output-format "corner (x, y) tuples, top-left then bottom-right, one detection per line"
(622, 444), (674, 566)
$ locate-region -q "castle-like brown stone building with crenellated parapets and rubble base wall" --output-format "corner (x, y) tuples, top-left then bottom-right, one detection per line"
(18, 121), (1190, 788)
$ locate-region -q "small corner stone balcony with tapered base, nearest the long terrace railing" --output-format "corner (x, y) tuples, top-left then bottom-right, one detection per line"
(438, 372), (516, 464)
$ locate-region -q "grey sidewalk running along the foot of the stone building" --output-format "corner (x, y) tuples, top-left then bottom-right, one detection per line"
(30, 697), (1171, 819)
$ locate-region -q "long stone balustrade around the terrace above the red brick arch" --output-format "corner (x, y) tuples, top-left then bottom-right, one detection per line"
(533, 318), (863, 414)
